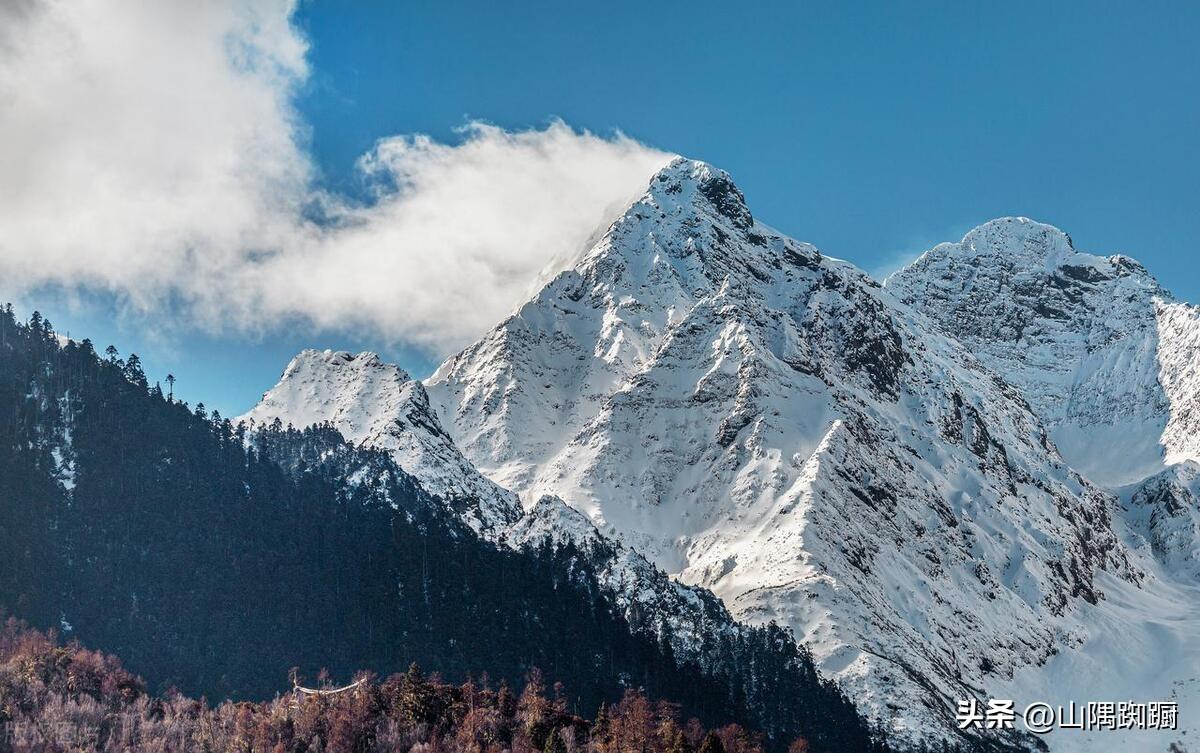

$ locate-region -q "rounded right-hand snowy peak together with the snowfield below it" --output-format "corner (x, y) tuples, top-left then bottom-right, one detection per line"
(886, 217), (1200, 749)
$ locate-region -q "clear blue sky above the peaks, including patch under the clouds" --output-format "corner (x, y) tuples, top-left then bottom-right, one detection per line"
(2, 0), (1200, 412)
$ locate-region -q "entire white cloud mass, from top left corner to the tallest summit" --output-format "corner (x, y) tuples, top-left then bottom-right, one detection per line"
(0, 0), (668, 351)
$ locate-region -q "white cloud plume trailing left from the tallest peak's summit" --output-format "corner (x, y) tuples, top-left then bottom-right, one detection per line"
(259, 122), (668, 347)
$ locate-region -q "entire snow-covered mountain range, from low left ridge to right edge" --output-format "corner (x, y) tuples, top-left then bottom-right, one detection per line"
(238, 159), (1200, 749)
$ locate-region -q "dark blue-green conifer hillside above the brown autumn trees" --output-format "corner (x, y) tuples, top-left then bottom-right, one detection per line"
(0, 307), (907, 751)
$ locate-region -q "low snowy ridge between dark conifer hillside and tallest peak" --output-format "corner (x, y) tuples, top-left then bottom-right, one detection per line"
(238, 350), (733, 658)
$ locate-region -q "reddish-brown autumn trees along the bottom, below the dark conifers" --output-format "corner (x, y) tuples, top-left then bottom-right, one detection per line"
(0, 620), (805, 753)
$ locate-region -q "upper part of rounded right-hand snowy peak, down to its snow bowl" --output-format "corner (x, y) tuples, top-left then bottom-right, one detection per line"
(887, 217), (1200, 487)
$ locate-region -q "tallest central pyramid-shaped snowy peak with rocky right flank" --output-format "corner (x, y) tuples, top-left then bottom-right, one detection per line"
(426, 159), (1142, 748)
